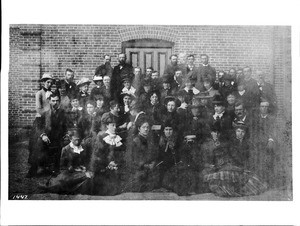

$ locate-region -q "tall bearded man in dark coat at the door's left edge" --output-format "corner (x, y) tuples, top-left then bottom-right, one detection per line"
(110, 53), (134, 103)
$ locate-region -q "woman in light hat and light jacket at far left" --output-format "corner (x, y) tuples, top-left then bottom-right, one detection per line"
(35, 73), (54, 117)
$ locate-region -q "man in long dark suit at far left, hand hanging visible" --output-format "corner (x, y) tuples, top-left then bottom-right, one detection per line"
(27, 93), (67, 177)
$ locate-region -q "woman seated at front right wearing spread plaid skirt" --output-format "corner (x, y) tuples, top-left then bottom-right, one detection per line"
(202, 125), (267, 197)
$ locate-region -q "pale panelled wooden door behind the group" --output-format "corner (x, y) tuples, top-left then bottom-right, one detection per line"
(125, 48), (172, 76)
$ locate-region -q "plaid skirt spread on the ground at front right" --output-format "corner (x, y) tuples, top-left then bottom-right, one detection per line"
(204, 165), (268, 197)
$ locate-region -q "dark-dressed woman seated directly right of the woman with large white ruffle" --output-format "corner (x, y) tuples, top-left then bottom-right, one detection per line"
(122, 117), (159, 192)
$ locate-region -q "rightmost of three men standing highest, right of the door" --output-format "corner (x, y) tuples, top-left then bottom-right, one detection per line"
(196, 54), (216, 90)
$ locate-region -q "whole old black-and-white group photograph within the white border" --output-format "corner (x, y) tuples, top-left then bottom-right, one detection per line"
(1, 0), (299, 223)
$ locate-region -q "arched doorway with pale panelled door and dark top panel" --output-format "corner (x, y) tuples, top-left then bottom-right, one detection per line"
(122, 39), (174, 75)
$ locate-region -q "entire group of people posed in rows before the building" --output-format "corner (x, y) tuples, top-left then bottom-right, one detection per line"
(27, 53), (277, 197)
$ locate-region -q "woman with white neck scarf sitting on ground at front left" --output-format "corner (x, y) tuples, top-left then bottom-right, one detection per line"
(40, 130), (92, 194)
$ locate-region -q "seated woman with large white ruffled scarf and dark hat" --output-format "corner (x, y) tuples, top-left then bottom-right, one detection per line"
(90, 114), (126, 195)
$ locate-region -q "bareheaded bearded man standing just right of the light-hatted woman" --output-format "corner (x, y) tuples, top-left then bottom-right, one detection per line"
(56, 68), (76, 109)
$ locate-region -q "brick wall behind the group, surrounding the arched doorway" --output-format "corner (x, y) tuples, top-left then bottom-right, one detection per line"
(9, 25), (291, 126)
